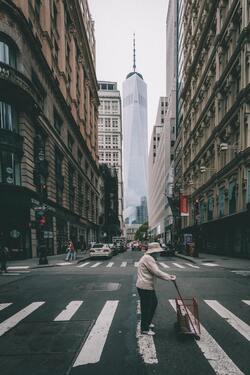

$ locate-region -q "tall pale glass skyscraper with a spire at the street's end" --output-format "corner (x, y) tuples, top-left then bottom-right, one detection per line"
(123, 39), (148, 223)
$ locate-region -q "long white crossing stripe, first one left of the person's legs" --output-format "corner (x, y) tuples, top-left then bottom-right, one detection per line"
(73, 301), (119, 367)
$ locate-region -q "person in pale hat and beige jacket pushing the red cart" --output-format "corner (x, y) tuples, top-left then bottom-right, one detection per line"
(136, 242), (176, 336)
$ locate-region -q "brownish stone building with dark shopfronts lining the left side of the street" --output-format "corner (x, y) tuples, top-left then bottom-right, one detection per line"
(0, 0), (99, 258)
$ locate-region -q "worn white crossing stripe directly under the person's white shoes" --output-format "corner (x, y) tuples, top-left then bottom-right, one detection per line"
(136, 300), (158, 364)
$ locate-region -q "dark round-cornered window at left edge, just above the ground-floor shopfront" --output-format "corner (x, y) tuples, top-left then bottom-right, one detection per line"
(0, 151), (21, 185)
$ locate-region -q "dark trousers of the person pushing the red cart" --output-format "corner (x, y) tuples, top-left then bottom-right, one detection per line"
(137, 288), (158, 331)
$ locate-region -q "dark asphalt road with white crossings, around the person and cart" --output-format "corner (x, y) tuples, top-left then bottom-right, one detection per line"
(0, 251), (250, 375)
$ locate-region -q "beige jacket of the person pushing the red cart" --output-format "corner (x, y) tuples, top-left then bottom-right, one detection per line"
(136, 254), (170, 290)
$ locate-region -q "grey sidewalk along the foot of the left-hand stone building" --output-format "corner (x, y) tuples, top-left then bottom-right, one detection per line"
(7, 251), (89, 268)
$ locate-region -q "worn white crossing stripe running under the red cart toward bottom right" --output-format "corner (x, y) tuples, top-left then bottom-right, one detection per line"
(169, 299), (244, 375)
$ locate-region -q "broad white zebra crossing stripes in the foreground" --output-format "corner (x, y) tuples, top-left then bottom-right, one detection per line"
(0, 299), (250, 375)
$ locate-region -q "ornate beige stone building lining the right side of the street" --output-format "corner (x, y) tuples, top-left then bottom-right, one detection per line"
(175, 0), (250, 257)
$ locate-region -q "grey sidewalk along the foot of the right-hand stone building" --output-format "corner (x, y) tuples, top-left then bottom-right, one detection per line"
(175, 252), (250, 270)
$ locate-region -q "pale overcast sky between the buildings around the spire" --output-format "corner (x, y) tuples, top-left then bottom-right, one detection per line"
(88, 0), (168, 142)
